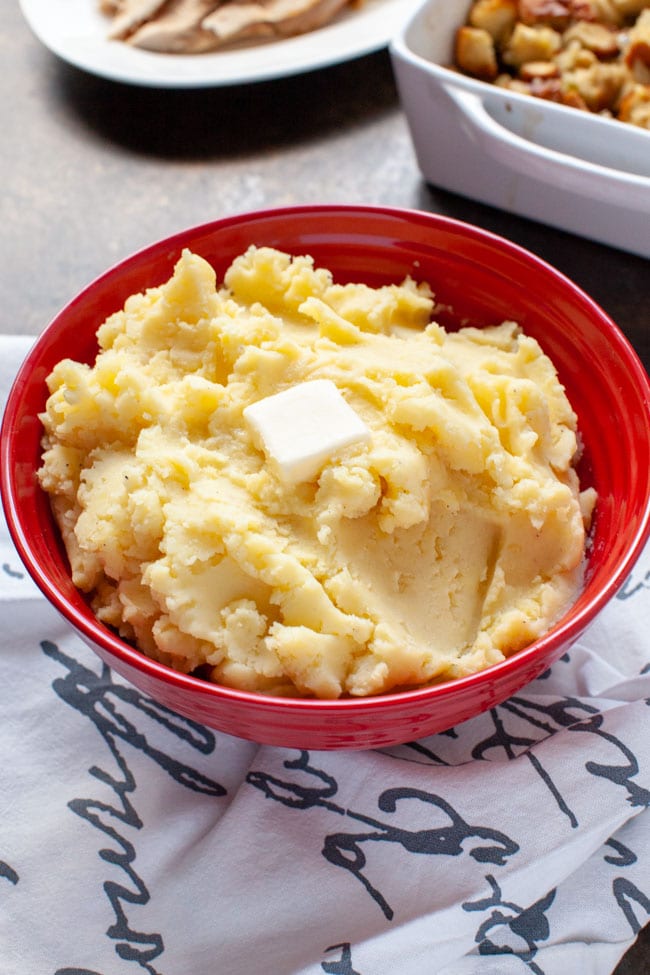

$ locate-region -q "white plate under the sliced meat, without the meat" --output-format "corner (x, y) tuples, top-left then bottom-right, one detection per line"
(20, 0), (417, 88)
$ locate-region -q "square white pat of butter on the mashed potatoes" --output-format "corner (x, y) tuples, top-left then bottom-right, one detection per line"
(244, 379), (370, 484)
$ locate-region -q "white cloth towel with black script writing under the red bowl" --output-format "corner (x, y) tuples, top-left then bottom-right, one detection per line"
(0, 338), (650, 975)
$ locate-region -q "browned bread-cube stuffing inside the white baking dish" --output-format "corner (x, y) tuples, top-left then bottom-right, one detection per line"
(455, 0), (650, 129)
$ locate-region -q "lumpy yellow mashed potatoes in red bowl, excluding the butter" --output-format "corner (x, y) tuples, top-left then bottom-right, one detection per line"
(39, 247), (593, 698)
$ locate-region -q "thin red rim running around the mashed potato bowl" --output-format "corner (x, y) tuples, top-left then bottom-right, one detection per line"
(0, 203), (650, 713)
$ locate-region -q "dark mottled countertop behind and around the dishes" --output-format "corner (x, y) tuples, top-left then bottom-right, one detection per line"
(0, 0), (650, 975)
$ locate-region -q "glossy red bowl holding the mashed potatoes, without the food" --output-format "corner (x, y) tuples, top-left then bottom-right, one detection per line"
(1, 206), (650, 749)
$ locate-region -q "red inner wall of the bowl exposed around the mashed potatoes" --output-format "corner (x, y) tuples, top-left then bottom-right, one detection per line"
(2, 206), (650, 736)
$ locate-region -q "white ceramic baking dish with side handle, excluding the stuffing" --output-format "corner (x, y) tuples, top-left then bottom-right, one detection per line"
(390, 0), (650, 257)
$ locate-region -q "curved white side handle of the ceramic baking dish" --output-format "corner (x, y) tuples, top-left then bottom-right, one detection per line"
(445, 85), (650, 213)
